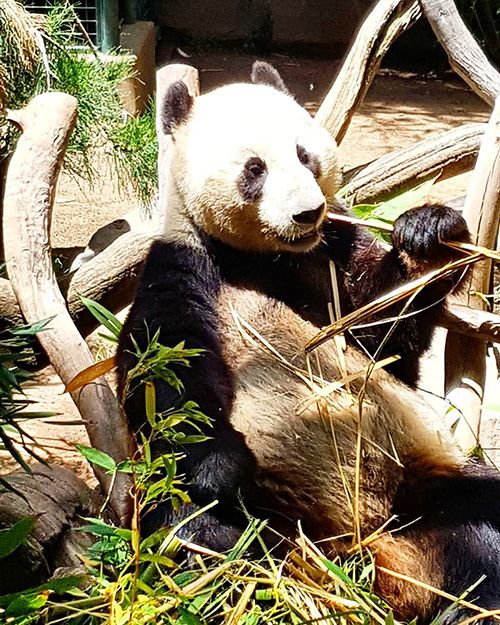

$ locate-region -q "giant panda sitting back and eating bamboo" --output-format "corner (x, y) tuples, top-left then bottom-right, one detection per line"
(117, 62), (500, 623)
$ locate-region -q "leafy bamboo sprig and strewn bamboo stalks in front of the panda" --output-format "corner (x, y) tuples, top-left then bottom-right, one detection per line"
(0, 300), (468, 625)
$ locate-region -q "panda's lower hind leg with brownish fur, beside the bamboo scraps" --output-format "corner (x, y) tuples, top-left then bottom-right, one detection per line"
(373, 522), (500, 625)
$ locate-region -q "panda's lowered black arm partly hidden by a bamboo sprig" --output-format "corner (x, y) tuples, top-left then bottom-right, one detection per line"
(117, 242), (254, 549)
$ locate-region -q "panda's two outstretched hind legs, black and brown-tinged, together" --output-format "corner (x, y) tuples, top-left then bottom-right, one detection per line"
(373, 462), (500, 625)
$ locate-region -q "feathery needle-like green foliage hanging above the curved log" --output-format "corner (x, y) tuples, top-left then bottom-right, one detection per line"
(0, 0), (158, 202)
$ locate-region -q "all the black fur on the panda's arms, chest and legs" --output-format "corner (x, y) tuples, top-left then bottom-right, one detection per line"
(117, 206), (500, 625)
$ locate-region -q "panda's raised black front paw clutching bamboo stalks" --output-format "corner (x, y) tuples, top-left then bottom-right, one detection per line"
(392, 204), (470, 262)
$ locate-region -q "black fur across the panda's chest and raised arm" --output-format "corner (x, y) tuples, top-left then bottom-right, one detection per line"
(201, 202), (468, 386)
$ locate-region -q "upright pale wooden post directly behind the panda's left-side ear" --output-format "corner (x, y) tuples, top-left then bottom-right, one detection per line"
(152, 63), (200, 234)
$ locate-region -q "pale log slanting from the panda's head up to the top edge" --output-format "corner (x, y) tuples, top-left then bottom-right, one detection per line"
(316, 0), (420, 144)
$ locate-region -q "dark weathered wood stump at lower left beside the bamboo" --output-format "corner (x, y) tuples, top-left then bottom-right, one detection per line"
(0, 464), (100, 594)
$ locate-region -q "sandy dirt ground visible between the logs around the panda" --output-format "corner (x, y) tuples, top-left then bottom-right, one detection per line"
(0, 46), (488, 478)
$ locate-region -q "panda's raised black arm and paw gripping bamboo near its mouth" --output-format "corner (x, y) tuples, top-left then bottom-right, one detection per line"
(325, 205), (469, 385)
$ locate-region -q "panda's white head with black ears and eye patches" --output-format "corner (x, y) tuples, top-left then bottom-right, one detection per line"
(162, 62), (338, 252)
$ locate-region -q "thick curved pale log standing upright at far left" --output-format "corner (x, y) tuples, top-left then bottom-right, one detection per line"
(3, 93), (131, 523)
